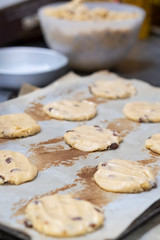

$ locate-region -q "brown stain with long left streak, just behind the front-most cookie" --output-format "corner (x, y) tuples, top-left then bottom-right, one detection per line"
(12, 157), (121, 217)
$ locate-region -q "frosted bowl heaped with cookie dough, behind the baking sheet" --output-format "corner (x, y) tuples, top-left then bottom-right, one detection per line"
(38, 0), (145, 71)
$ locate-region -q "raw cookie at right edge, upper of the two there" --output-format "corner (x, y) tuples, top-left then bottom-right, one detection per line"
(123, 102), (160, 123)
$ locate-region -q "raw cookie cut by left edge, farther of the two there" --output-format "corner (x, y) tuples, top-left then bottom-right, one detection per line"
(0, 113), (41, 138)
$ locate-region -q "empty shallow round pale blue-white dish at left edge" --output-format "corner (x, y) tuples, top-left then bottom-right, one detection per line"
(0, 47), (68, 89)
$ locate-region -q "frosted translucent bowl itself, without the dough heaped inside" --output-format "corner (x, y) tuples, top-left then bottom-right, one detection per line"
(38, 2), (145, 71)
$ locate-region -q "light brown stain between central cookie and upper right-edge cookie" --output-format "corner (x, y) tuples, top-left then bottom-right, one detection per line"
(107, 118), (140, 137)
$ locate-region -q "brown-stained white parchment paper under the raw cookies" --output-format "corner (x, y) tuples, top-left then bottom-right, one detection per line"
(0, 71), (160, 240)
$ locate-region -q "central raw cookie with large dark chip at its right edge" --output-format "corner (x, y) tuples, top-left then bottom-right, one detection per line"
(64, 125), (122, 152)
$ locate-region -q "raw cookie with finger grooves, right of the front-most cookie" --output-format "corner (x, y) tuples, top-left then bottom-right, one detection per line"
(94, 159), (156, 193)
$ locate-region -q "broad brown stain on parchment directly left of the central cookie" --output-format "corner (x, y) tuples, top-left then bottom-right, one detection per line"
(28, 137), (89, 171)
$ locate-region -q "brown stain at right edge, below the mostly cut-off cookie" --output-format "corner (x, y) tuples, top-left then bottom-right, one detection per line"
(138, 148), (160, 174)
